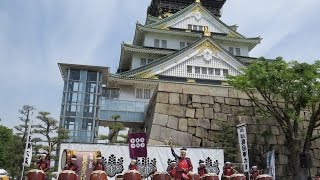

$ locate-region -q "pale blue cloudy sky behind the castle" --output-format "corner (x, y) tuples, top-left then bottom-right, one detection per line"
(0, 0), (320, 127)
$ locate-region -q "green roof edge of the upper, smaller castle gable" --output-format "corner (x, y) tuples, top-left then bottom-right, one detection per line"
(146, 2), (245, 38)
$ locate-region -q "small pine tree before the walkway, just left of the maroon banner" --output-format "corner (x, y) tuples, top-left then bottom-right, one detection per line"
(99, 115), (127, 143)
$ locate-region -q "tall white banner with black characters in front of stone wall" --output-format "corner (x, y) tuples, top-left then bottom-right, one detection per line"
(237, 124), (250, 172)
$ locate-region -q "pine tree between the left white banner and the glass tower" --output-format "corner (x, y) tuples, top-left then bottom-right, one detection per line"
(33, 112), (69, 155)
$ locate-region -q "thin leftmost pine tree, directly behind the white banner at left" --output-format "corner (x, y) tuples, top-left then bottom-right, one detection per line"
(14, 105), (35, 143)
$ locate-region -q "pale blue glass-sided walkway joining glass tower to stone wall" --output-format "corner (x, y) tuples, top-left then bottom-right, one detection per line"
(99, 99), (148, 123)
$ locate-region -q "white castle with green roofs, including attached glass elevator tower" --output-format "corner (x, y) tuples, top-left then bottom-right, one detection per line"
(59, 0), (261, 142)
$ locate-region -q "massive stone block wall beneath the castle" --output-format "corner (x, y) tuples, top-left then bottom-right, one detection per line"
(146, 83), (320, 179)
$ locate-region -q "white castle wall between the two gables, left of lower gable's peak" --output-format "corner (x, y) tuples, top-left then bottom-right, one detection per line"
(143, 34), (196, 49)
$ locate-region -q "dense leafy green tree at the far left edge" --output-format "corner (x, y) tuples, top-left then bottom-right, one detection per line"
(0, 125), (24, 179)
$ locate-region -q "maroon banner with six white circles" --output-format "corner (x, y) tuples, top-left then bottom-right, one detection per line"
(128, 133), (147, 158)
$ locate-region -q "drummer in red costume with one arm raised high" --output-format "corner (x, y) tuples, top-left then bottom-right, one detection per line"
(170, 144), (193, 179)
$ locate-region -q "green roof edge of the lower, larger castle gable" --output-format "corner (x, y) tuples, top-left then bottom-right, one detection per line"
(119, 37), (244, 77)
